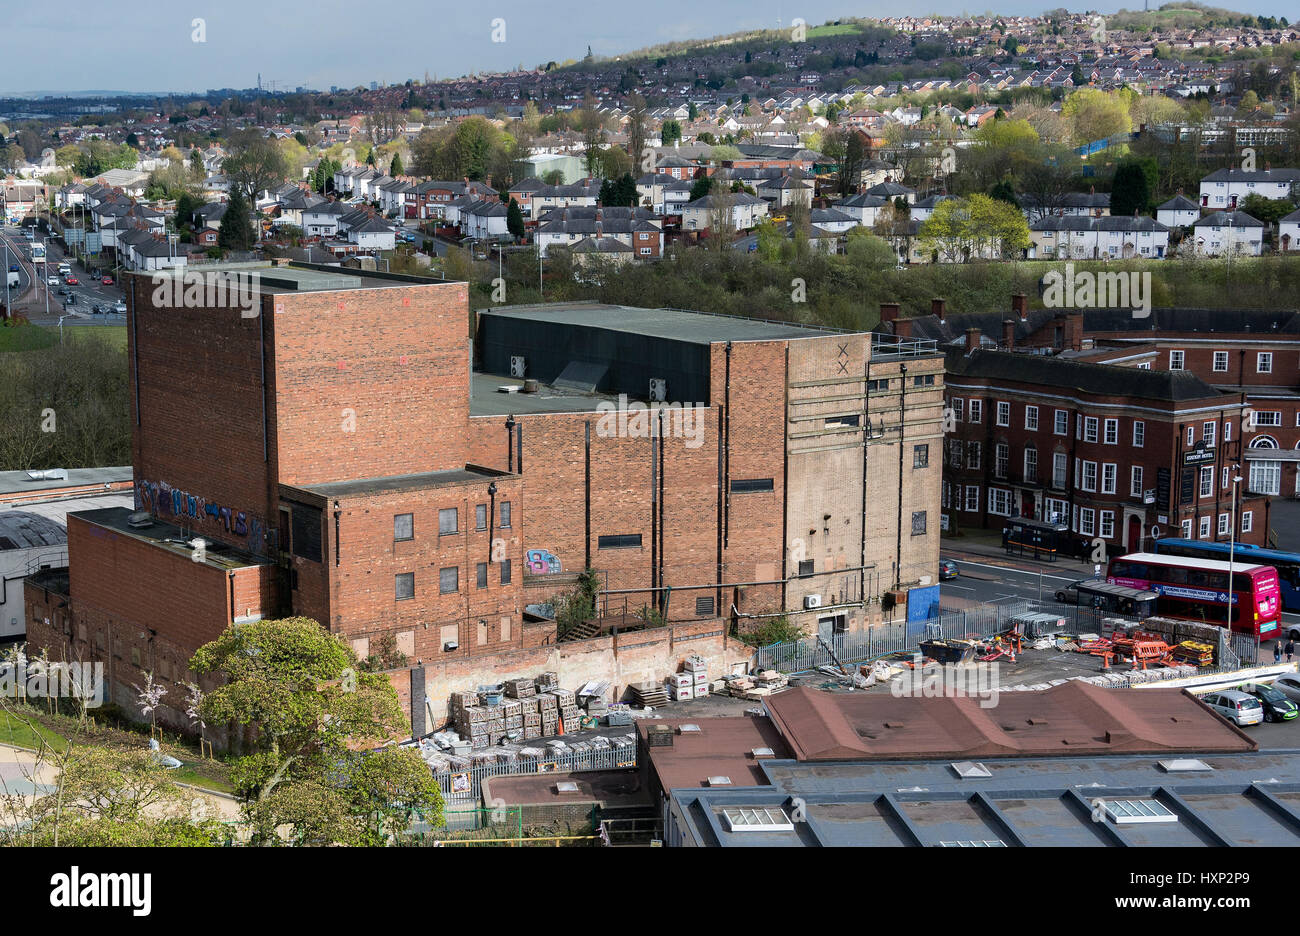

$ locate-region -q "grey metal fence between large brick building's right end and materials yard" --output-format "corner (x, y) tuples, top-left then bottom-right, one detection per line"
(753, 601), (1034, 673)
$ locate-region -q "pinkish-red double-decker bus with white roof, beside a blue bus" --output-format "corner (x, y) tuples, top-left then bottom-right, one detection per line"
(1106, 553), (1282, 640)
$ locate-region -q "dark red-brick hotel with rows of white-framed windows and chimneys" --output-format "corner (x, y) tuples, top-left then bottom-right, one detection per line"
(884, 296), (1274, 553)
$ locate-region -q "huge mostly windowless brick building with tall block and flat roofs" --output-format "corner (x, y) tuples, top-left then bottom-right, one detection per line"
(26, 264), (944, 722)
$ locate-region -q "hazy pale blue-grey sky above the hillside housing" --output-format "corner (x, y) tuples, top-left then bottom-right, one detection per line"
(0, 0), (1300, 94)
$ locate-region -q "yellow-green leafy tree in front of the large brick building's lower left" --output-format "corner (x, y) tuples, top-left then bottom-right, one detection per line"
(190, 618), (442, 845)
